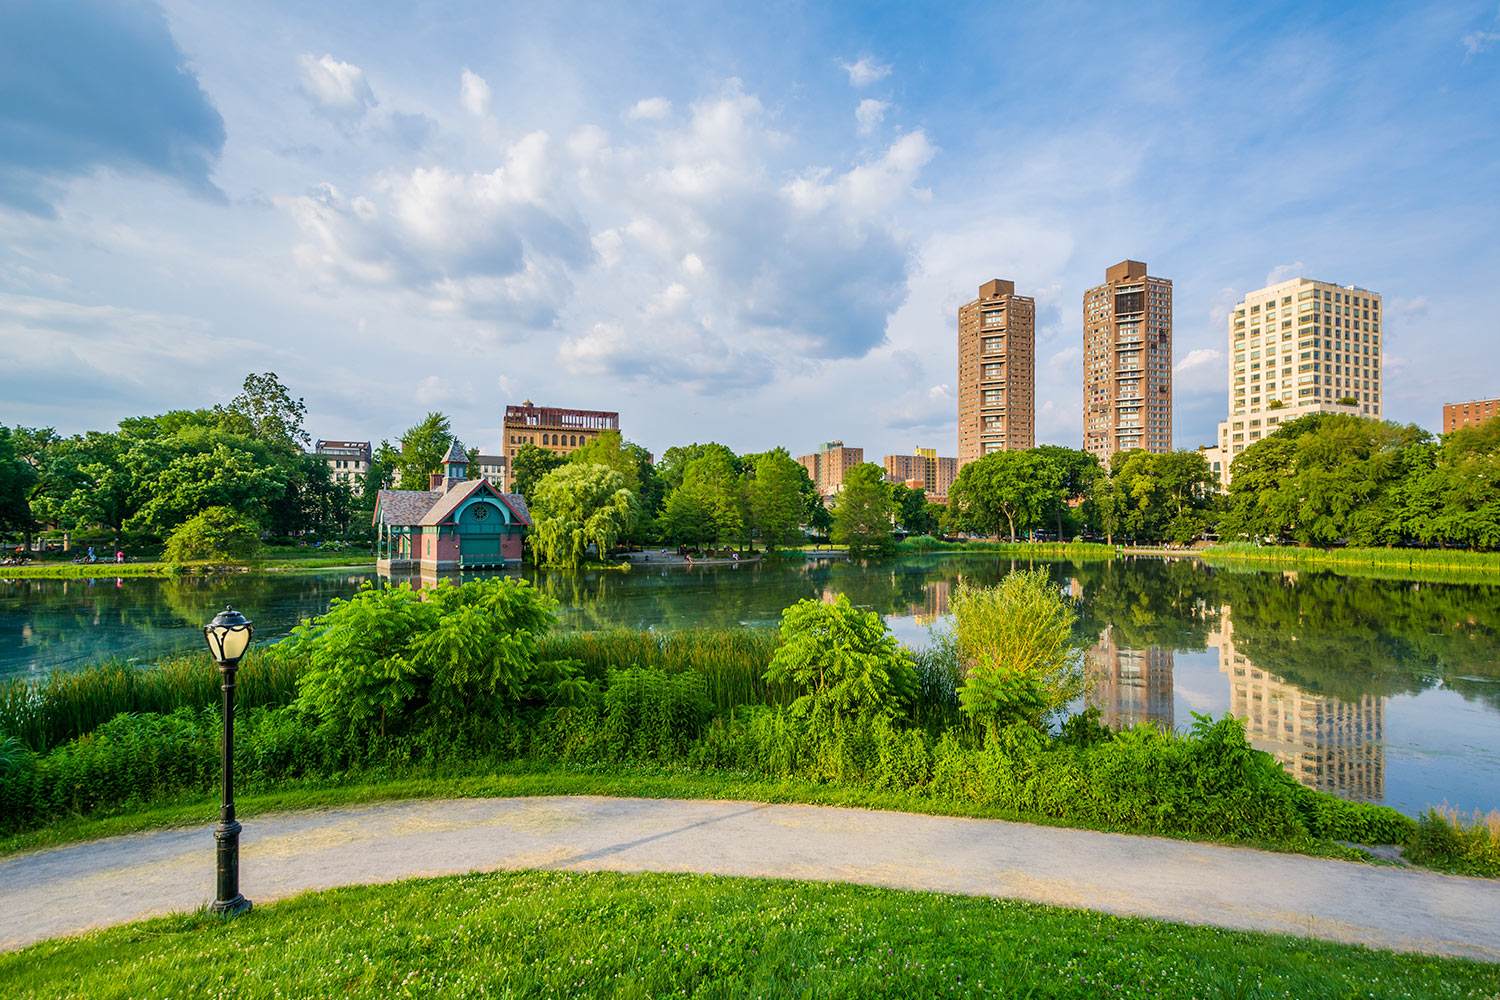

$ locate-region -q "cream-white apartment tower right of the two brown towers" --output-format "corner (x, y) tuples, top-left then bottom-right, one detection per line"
(1205, 277), (1382, 486)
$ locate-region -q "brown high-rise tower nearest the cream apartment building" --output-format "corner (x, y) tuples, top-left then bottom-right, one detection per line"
(1083, 261), (1172, 465)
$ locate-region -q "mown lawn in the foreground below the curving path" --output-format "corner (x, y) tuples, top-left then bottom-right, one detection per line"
(0, 871), (1500, 1000)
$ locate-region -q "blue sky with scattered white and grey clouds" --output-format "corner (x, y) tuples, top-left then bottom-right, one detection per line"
(0, 0), (1500, 462)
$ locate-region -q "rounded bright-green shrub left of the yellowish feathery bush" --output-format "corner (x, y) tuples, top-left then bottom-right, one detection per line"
(765, 594), (917, 718)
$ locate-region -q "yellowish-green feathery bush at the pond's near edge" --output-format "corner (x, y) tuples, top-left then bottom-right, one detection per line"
(948, 570), (1085, 733)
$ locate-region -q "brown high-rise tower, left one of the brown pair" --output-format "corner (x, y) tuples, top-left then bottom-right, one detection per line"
(959, 279), (1037, 468)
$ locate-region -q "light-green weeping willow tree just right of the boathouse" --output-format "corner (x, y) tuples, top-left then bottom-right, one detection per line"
(533, 463), (639, 570)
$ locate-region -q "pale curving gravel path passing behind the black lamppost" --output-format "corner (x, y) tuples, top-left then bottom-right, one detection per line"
(0, 798), (1500, 961)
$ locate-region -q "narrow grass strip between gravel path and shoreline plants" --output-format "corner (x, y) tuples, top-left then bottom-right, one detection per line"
(0, 760), (1373, 861)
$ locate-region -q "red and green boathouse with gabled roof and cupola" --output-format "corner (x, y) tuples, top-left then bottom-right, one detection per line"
(374, 441), (531, 573)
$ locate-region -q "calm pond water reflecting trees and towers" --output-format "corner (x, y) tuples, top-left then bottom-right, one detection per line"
(0, 556), (1500, 813)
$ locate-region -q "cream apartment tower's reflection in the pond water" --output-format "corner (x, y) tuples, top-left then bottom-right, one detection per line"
(1209, 606), (1386, 802)
